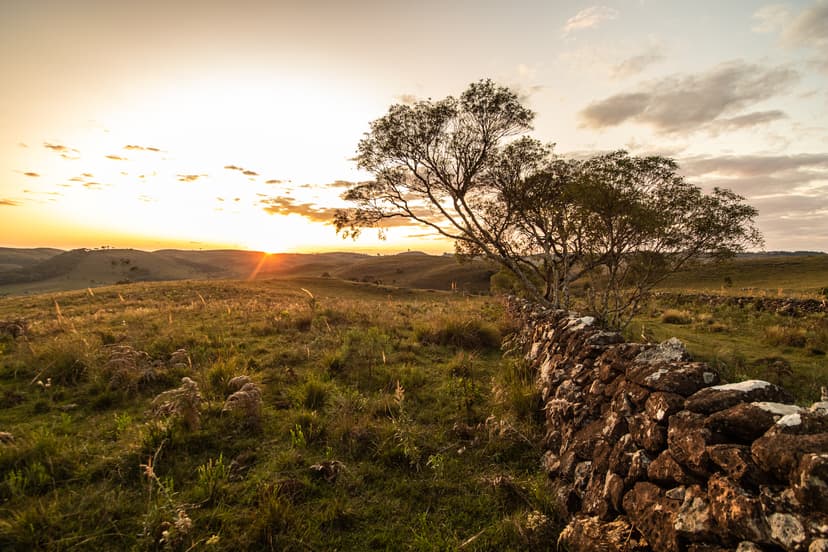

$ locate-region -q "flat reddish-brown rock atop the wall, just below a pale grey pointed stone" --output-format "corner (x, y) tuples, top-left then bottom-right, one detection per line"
(627, 362), (719, 397)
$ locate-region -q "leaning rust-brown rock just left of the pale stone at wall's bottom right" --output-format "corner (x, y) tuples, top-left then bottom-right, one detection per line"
(707, 474), (770, 543)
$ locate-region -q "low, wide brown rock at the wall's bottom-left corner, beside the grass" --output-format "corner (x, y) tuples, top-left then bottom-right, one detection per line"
(558, 516), (651, 552)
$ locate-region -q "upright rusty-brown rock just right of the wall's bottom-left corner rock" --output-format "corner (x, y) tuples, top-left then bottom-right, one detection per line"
(623, 482), (680, 552)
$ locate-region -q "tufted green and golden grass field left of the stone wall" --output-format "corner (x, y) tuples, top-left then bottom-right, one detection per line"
(0, 278), (555, 550)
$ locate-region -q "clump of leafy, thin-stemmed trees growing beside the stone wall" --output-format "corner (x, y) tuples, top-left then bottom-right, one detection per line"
(334, 80), (761, 326)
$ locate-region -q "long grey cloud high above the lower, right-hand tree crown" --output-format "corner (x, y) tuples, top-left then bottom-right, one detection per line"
(580, 61), (799, 134)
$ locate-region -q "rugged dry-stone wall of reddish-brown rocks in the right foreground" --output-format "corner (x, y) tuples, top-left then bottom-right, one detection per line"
(512, 301), (828, 552)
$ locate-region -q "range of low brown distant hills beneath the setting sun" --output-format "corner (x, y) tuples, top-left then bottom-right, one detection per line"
(0, 249), (494, 294)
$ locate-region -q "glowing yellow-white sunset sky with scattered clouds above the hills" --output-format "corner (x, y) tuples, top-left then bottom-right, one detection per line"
(0, 0), (828, 252)
